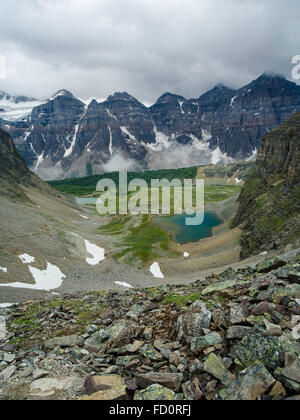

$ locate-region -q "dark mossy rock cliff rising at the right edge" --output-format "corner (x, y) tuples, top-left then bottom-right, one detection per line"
(233, 113), (300, 257)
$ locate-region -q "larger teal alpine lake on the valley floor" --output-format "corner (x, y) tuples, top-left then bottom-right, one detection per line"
(153, 212), (223, 245)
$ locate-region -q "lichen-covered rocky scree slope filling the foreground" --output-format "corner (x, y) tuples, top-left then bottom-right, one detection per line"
(0, 250), (300, 400)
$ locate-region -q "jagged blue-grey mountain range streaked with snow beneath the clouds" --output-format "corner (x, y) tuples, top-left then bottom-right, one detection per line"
(0, 74), (300, 179)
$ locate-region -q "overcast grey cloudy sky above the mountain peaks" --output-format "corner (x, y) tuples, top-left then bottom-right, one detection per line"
(0, 0), (300, 103)
